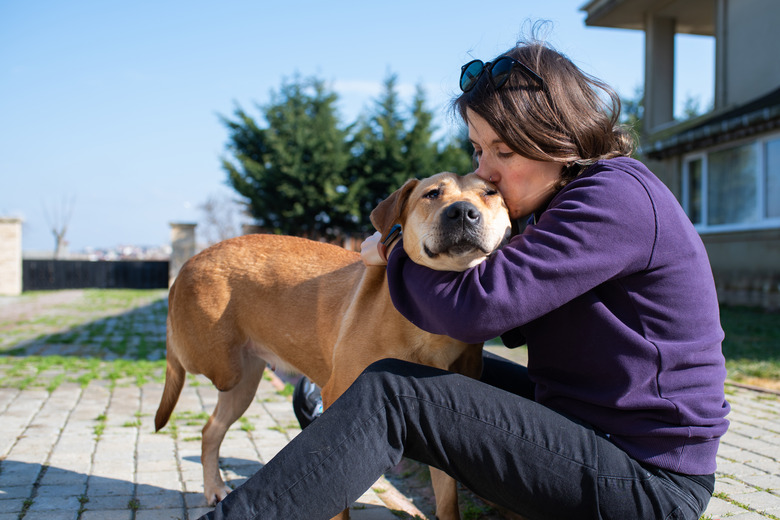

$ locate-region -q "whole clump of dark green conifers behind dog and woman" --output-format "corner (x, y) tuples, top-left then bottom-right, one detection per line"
(222, 75), (472, 238)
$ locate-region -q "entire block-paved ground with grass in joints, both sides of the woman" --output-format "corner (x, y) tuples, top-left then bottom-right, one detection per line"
(0, 293), (780, 520)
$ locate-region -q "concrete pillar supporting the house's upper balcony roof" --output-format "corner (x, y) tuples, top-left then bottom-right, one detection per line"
(644, 13), (675, 133)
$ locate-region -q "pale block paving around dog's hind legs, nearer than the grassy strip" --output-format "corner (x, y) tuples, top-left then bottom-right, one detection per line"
(0, 372), (420, 520)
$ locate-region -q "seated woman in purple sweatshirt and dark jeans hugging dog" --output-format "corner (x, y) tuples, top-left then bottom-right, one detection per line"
(204, 36), (729, 520)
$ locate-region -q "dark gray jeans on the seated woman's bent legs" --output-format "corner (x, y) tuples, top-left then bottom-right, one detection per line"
(203, 355), (714, 520)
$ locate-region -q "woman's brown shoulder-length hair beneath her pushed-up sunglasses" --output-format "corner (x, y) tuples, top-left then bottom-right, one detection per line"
(453, 36), (634, 187)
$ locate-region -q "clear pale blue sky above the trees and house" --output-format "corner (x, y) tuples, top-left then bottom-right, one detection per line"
(0, 0), (714, 251)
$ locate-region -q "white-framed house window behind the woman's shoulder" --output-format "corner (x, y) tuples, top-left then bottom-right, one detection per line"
(682, 135), (780, 231)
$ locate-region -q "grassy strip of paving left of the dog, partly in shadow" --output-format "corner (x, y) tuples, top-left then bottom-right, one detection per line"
(0, 289), (167, 392)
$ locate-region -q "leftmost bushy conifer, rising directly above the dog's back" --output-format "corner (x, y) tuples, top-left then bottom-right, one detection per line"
(222, 78), (358, 238)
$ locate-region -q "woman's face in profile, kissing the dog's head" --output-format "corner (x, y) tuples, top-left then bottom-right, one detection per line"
(467, 110), (563, 219)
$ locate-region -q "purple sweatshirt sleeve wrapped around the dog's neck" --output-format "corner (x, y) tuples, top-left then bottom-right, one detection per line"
(387, 163), (657, 343)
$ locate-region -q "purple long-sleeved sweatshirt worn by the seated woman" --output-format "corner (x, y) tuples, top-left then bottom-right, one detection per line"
(387, 157), (729, 475)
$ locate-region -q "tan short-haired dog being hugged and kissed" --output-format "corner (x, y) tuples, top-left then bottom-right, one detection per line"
(155, 173), (510, 520)
